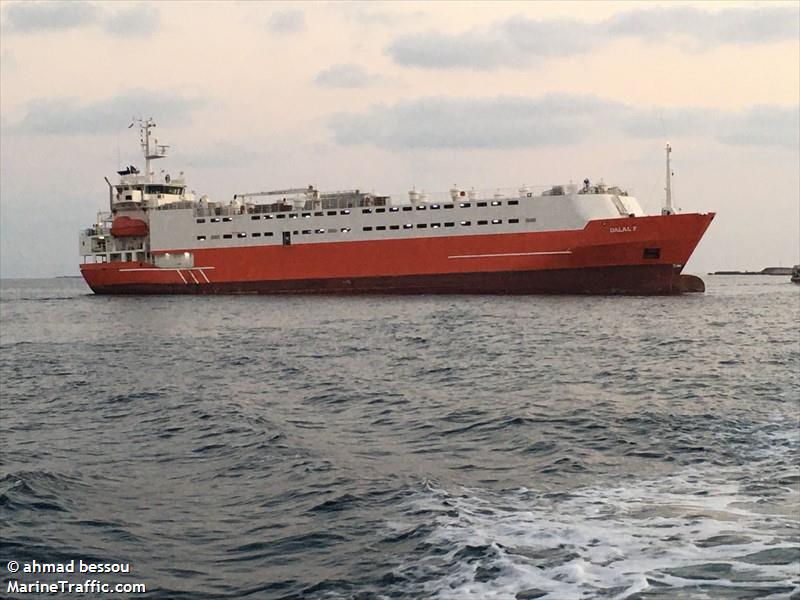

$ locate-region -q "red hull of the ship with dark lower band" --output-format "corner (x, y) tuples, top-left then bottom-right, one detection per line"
(81, 214), (714, 294)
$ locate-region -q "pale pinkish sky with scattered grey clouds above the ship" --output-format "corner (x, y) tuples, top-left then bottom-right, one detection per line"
(0, 0), (800, 277)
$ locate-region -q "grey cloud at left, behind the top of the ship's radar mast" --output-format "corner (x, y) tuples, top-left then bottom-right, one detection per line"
(5, 90), (205, 135)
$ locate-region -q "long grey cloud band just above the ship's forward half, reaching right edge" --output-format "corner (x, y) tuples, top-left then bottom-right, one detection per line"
(329, 94), (800, 150)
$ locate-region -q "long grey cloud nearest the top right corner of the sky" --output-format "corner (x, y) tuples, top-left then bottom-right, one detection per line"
(386, 6), (800, 70)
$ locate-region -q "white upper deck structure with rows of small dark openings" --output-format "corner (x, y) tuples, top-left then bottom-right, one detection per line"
(150, 188), (644, 252)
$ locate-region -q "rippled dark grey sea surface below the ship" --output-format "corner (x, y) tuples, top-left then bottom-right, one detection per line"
(0, 277), (800, 600)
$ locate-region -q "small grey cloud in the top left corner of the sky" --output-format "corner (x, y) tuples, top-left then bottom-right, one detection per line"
(4, 0), (100, 32)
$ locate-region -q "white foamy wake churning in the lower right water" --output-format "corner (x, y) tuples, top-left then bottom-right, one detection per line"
(396, 458), (800, 600)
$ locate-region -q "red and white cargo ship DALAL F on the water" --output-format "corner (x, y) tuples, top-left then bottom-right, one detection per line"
(79, 119), (714, 295)
